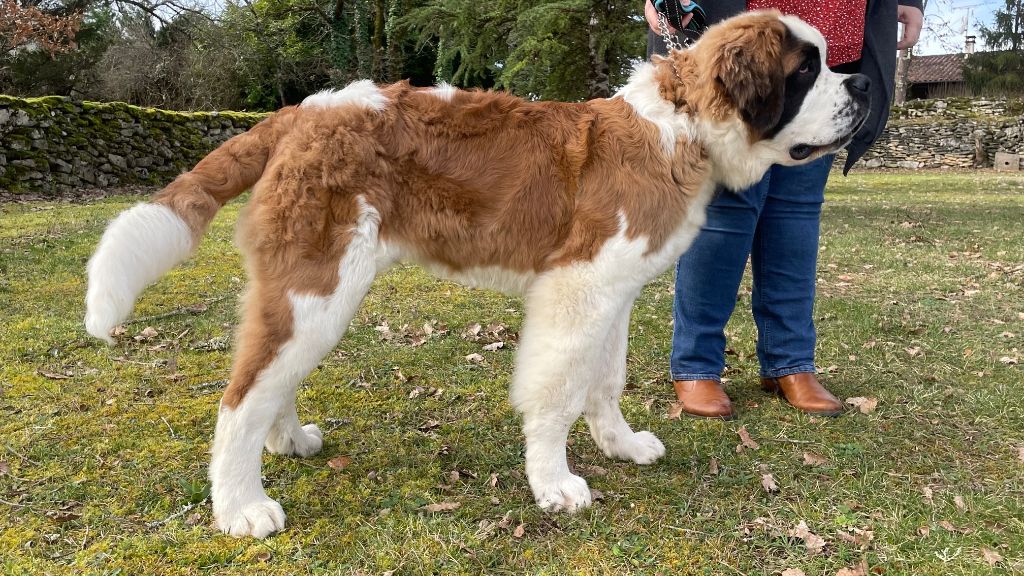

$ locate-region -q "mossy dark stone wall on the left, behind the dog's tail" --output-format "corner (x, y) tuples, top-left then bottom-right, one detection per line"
(0, 95), (266, 194)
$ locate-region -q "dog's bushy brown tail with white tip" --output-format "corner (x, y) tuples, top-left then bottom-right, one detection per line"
(85, 109), (295, 344)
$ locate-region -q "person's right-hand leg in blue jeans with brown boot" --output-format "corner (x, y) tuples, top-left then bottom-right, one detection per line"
(751, 156), (842, 413)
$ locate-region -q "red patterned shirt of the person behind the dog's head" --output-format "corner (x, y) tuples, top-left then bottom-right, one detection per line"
(746, 0), (867, 66)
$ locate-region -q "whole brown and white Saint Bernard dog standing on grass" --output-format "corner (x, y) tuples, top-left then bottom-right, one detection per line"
(85, 11), (869, 537)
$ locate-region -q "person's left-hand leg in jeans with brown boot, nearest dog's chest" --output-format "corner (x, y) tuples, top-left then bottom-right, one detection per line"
(670, 175), (769, 417)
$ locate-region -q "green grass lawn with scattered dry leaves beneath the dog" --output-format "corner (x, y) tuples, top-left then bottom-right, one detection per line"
(0, 173), (1024, 576)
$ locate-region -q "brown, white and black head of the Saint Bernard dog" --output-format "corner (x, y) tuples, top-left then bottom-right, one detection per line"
(654, 11), (870, 189)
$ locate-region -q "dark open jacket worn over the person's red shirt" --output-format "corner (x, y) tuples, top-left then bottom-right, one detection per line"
(647, 0), (923, 174)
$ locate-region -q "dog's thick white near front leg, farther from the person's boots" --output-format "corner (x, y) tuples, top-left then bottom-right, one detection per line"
(510, 269), (621, 511)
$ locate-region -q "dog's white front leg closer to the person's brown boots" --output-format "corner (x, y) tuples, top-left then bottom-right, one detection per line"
(584, 299), (665, 464)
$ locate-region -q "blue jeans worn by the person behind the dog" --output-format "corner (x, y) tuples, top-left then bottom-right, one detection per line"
(671, 155), (833, 380)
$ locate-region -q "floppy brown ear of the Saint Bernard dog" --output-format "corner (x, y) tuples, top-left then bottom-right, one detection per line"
(714, 17), (787, 134)
